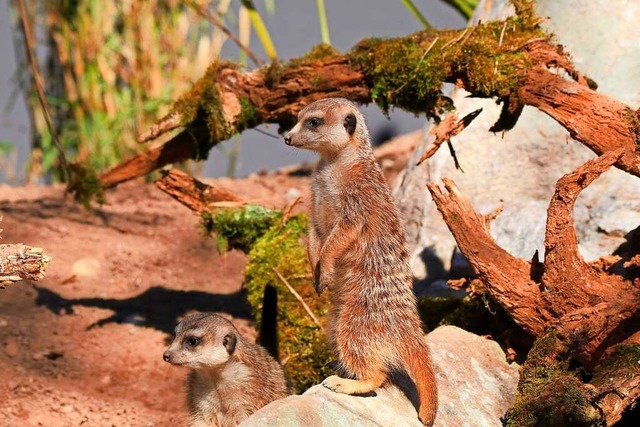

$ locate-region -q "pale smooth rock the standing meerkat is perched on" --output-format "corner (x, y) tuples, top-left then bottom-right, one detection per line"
(241, 326), (519, 427)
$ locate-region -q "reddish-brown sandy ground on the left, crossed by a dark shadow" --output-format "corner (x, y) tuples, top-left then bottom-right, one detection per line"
(0, 175), (308, 427)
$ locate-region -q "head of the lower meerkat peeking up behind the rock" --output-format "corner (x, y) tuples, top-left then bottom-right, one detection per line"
(162, 313), (239, 369)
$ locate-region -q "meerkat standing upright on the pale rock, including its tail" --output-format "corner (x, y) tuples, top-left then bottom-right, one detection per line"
(285, 98), (438, 425)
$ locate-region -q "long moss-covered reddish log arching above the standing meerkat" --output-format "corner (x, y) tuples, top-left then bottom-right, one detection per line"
(101, 10), (640, 187)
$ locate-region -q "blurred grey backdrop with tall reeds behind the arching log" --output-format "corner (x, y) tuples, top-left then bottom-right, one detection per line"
(0, 0), (470, 185)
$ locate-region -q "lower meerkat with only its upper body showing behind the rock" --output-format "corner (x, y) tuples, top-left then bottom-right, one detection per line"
(163, 313), (291, 427)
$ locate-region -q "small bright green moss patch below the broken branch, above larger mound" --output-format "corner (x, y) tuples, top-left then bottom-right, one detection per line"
(202, 205), (282, 253)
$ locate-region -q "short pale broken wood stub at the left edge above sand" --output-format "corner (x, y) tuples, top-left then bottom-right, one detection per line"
(0, 244), (51, 288)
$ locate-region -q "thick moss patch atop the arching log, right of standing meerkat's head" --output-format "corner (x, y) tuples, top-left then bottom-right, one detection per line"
(347, 18), (546, 114)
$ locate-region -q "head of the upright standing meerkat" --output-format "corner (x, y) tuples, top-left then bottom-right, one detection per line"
(284, 98), (369, 155)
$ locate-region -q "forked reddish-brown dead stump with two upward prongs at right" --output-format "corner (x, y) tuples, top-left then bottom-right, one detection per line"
(428, 148), (640, 425)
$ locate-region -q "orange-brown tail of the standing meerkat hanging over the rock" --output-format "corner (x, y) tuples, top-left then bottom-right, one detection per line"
(404, 341), (438, 426)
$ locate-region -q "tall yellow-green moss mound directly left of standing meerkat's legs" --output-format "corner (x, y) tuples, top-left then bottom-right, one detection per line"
(245, 215), (332, 391)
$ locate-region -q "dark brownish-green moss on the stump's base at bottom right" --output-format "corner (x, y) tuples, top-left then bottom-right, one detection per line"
(506, 332), (603, 427)
